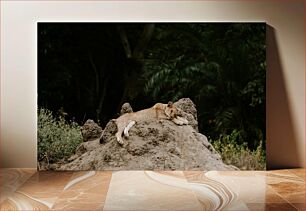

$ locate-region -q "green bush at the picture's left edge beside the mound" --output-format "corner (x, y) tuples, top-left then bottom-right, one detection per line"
(37, 108), (82, 164)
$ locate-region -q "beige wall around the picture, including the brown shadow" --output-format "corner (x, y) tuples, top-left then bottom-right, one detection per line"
(1, 1), (305, 169)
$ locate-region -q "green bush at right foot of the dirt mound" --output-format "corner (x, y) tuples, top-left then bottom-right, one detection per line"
(211, 130), (266, 170)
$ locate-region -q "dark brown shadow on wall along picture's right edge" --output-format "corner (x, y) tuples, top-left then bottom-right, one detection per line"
(266, 25), (299, 170)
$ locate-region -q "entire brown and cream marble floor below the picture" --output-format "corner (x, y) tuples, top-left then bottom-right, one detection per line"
(0, 169), (306, 211)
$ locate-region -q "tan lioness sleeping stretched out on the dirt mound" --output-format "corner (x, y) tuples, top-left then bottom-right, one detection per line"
(115, 102), (188, 144)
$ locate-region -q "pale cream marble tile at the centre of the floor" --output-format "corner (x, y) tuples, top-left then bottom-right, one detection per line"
(104, 171), (201, 210)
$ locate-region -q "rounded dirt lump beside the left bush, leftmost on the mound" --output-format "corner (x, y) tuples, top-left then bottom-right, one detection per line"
(81, 119), (103, 142)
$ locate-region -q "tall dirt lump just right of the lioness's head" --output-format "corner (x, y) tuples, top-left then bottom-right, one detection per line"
(174, 98), (199, 132)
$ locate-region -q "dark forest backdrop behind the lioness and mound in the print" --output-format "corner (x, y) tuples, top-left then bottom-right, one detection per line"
(38, 23), (266, 152)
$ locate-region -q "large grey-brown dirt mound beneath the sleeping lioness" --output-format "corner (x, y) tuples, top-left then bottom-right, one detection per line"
(59, 99), (237, 171)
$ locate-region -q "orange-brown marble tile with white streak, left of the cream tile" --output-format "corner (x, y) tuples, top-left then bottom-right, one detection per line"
(0, 171), (111, 210)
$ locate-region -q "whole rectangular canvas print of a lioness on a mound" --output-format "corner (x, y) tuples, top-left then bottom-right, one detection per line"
(37, 22), (266, 171)
